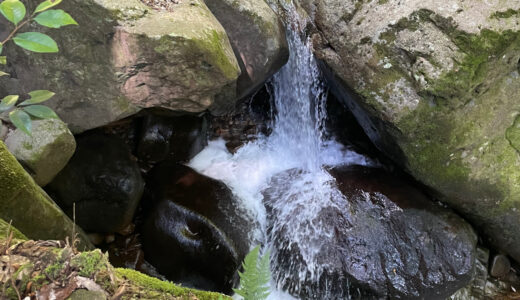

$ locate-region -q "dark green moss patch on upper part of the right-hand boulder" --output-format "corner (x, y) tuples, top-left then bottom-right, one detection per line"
(375, 9), (520, 105)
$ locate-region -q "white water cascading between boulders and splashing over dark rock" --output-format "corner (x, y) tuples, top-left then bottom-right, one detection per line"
(189, 4), (372, 300)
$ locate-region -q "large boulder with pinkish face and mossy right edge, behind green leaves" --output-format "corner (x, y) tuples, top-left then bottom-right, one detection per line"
(0, 0), (240, 133)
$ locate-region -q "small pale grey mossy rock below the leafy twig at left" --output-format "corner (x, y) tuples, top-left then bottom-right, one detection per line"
(5, 119), (76, 186)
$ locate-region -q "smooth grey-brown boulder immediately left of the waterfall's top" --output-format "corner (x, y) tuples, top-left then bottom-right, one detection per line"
(206, 0), (289, 105)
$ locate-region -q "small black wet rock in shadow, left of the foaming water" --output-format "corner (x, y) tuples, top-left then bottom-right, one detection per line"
(137, 115), (208, 163)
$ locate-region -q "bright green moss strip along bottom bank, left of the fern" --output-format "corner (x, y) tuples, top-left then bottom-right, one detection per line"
(116, 269), (231, 300)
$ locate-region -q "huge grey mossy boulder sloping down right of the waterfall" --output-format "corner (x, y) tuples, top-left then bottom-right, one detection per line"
(294, 0), (520, 261)
